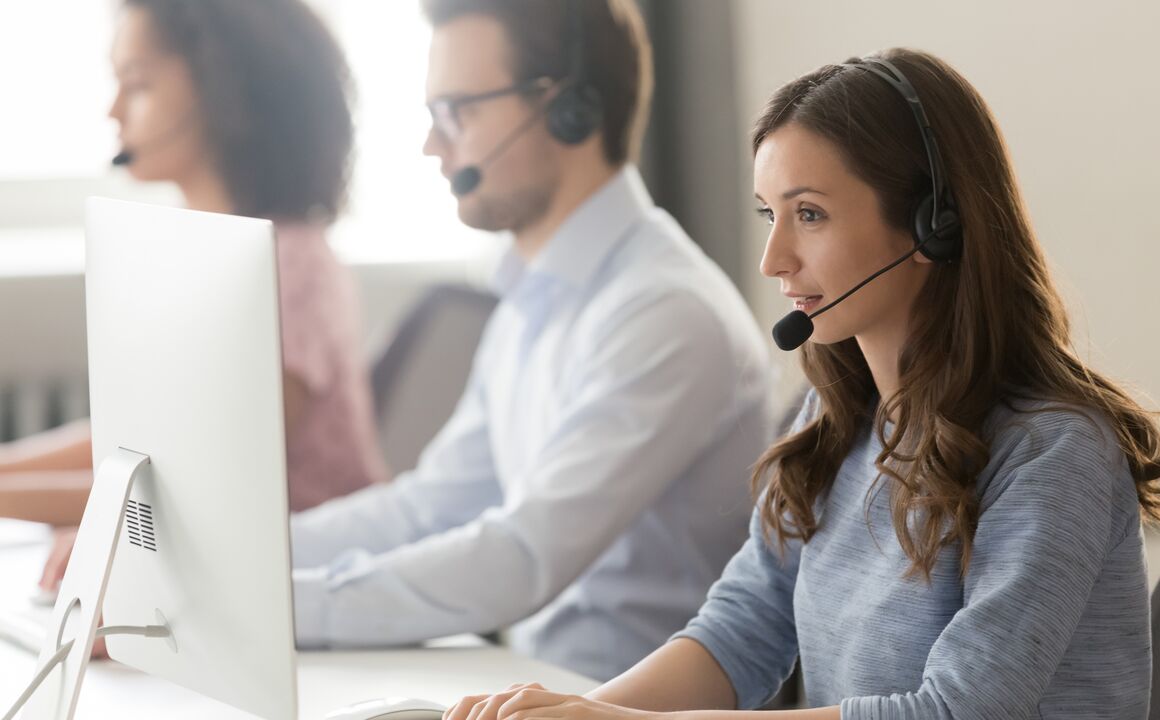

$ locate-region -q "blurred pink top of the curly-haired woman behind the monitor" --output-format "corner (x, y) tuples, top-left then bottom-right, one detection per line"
(277, 223), (387, 511)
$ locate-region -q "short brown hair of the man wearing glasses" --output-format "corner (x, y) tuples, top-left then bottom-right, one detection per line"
(422, 0), (653, 166)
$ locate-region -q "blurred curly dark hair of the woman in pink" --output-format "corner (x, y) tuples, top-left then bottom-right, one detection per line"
(124, 0), (354, 220)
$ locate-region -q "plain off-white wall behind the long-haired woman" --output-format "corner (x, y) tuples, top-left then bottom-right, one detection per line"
(734, 0), (1160, 407)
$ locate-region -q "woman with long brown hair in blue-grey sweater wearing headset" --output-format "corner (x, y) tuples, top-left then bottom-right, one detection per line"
(448, 50), (1160, 720)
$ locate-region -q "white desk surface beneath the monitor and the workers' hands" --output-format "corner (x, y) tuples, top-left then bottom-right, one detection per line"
(0, 521), (596, 720)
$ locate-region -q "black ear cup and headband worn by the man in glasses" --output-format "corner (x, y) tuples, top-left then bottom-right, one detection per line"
(545, 0), (604, 145)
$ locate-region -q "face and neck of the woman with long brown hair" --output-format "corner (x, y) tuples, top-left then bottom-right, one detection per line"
(753, 122), (930, 349)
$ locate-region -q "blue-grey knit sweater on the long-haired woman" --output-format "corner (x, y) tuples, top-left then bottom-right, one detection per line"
(677, 395), (1151, 720)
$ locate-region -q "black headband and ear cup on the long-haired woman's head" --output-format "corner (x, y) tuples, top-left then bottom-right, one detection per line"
(849, 58), (963, 263)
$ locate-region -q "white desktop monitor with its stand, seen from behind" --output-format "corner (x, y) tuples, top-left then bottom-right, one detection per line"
(26, 198), (297, 720)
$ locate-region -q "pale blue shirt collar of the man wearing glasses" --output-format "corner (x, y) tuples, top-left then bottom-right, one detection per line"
(494, 165), (654, 296)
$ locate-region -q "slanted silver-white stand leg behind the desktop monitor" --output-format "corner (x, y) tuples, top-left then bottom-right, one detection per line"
(23, 448), (150, 720)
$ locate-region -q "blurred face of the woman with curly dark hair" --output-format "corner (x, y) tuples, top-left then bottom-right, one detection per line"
(109, 7), (210, 182)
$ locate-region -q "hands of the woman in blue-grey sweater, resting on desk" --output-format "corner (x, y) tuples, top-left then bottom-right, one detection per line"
(443, 683), (657, 720)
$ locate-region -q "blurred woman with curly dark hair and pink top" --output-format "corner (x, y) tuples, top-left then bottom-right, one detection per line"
(0, 0), (386, 572)
